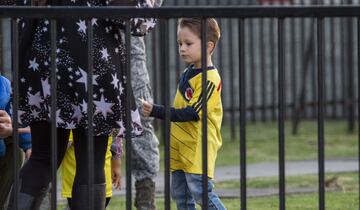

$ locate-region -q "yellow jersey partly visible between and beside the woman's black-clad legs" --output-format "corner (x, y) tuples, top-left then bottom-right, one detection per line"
(60, 132), (112, 198)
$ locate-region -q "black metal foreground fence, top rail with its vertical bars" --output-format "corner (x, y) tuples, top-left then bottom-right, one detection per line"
(0, 5), (360, 210)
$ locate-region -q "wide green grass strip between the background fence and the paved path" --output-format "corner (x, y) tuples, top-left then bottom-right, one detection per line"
(217, 121), (358, 166)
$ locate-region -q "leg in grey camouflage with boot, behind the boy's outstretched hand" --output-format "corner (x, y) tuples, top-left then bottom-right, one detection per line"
(131, 34), (159, 210)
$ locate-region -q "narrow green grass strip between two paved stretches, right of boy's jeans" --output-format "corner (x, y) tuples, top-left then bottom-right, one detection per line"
(215, 172), (359, 191)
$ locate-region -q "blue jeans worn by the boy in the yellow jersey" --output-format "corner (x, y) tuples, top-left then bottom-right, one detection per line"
(171, 170), (226, 210)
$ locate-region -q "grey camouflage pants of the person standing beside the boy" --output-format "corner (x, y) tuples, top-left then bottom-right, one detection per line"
(131, 36), (159, 181)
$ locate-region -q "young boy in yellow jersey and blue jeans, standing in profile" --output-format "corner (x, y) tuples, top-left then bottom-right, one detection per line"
(142, 18), (225, 209)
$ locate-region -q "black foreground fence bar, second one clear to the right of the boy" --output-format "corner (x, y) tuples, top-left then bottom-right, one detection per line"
(278, 18), (285, 210)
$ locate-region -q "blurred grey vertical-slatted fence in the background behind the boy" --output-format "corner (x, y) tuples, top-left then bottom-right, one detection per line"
(146, 0), (360, 138)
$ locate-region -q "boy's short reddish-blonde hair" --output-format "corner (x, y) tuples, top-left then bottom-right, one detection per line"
(178, 18), (221, 45)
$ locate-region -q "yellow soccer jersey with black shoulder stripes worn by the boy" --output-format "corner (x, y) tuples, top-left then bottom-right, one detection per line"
(170, 66), (223, 178)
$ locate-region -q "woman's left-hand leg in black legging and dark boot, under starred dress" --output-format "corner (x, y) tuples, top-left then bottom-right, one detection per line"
(9, 121), (69, 209)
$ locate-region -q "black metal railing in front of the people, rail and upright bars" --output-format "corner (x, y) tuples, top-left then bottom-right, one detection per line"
(0, 5), (360, 210)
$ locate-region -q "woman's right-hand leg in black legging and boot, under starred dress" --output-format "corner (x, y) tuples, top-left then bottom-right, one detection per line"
(71, 129), (108, 210)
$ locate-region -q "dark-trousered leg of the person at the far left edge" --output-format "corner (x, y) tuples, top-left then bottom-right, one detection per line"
(0, 142), (23, 209)
